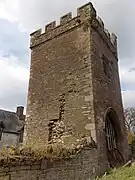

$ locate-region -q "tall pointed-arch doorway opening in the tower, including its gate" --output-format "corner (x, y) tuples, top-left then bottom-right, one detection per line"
(105, 108), (124, 167)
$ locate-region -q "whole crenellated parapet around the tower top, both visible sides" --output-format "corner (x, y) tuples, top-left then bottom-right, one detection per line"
(30, 2), (117, 52)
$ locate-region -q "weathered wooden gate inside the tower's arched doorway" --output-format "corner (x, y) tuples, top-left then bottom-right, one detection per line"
(105, 115), (124, 168)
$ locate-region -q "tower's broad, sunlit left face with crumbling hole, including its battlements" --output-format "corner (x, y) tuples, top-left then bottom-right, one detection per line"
(26, 3), (96, 144)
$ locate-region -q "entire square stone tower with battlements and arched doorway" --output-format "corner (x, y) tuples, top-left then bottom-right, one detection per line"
(25, 3), (128, 169)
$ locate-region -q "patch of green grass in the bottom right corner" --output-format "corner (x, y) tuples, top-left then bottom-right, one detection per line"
(97, 166), (135, 180)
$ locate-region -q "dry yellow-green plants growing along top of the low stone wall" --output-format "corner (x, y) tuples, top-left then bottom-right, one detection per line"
(0, 138), (96, 166)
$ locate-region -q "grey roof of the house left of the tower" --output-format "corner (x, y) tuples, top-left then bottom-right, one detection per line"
(0, 109), (24, 133)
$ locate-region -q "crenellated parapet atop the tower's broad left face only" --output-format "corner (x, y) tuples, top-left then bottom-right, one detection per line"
(30, 3), (96, 48)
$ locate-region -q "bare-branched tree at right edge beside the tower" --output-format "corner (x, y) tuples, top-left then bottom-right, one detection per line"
(124, 107), (135, 131)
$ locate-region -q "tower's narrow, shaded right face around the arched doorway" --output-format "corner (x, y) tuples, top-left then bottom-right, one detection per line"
(91, 18), (128, 161)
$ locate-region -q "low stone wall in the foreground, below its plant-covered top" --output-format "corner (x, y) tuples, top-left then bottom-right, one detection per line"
(0, 148), (105, 180)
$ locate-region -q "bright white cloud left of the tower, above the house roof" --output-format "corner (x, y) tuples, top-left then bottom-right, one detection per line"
(0, 56), (29, 110)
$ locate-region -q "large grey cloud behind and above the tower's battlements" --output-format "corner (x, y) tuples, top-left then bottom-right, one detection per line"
(1, 0), (135, 65)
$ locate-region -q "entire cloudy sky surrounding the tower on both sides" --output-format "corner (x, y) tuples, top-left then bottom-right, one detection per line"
(0, 0), (135, 110)
